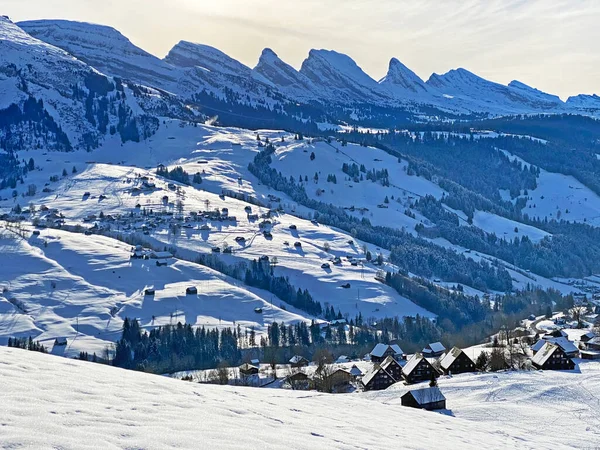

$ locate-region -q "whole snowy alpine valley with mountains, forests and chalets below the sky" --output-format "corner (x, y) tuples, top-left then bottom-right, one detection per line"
(0, 16), (600, 448)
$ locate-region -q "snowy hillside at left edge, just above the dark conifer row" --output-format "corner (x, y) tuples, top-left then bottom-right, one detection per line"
(0, 230), (305, 356)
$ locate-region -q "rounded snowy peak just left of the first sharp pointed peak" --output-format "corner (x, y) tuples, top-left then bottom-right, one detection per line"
(164, 41), (250, 76)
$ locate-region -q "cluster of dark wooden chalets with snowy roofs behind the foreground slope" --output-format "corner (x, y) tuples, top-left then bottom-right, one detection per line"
(233, 330), (600, 410)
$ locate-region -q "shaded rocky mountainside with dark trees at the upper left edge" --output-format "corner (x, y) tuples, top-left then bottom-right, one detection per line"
(0, 17), (196, 150)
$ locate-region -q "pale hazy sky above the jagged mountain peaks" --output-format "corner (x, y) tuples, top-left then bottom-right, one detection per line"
(0, 0), (600, 99)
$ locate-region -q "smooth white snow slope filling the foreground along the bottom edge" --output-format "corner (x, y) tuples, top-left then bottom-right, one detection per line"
(0, 348), (584, 450)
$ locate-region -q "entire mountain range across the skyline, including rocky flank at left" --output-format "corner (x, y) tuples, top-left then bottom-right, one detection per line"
(0, 16), (600, 148)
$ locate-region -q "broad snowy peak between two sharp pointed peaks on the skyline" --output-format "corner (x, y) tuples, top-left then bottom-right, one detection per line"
(300, 49), (390, 103)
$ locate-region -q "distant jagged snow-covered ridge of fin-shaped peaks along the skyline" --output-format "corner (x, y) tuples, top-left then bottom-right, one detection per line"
(15, 20), (600, 121)
